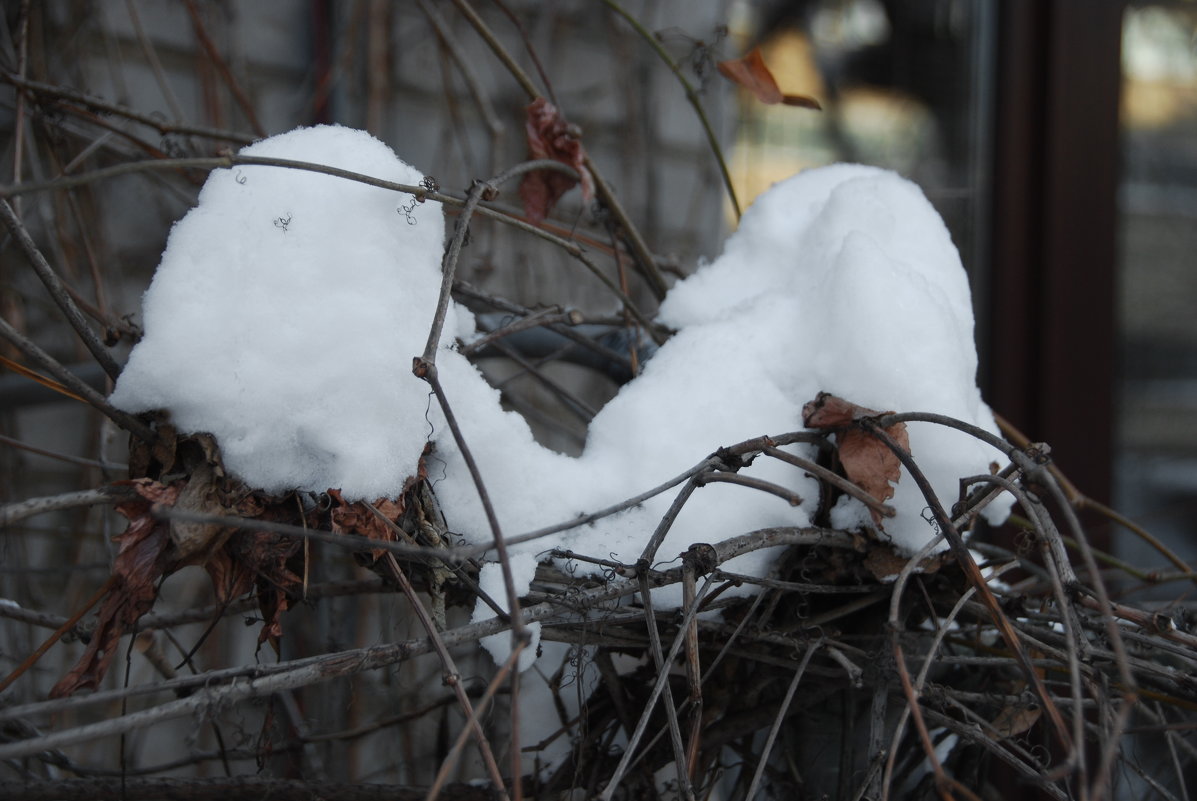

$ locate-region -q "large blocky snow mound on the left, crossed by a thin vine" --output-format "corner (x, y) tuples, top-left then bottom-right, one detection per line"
(113, 126), (457, 498)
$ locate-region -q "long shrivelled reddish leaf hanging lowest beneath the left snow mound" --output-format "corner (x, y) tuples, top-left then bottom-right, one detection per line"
(50, 479), (182, 698)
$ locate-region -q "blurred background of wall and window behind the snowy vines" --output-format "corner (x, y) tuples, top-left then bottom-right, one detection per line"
(0, 0), (1197, 785)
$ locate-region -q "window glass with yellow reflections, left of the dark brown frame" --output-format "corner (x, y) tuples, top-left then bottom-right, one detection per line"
(731, 0), (996, 285)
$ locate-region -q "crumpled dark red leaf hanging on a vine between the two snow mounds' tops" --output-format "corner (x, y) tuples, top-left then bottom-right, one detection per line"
(519, 97), (595, 223)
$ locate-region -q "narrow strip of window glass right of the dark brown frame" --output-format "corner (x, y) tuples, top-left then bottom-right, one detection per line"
(1114, 2), (1197, 586)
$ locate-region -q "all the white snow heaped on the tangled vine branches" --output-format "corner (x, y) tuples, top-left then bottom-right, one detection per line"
(113, 127), (1007, 661)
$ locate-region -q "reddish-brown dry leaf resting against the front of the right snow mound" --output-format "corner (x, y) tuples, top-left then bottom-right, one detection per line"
(802, 393), (910, 529)
